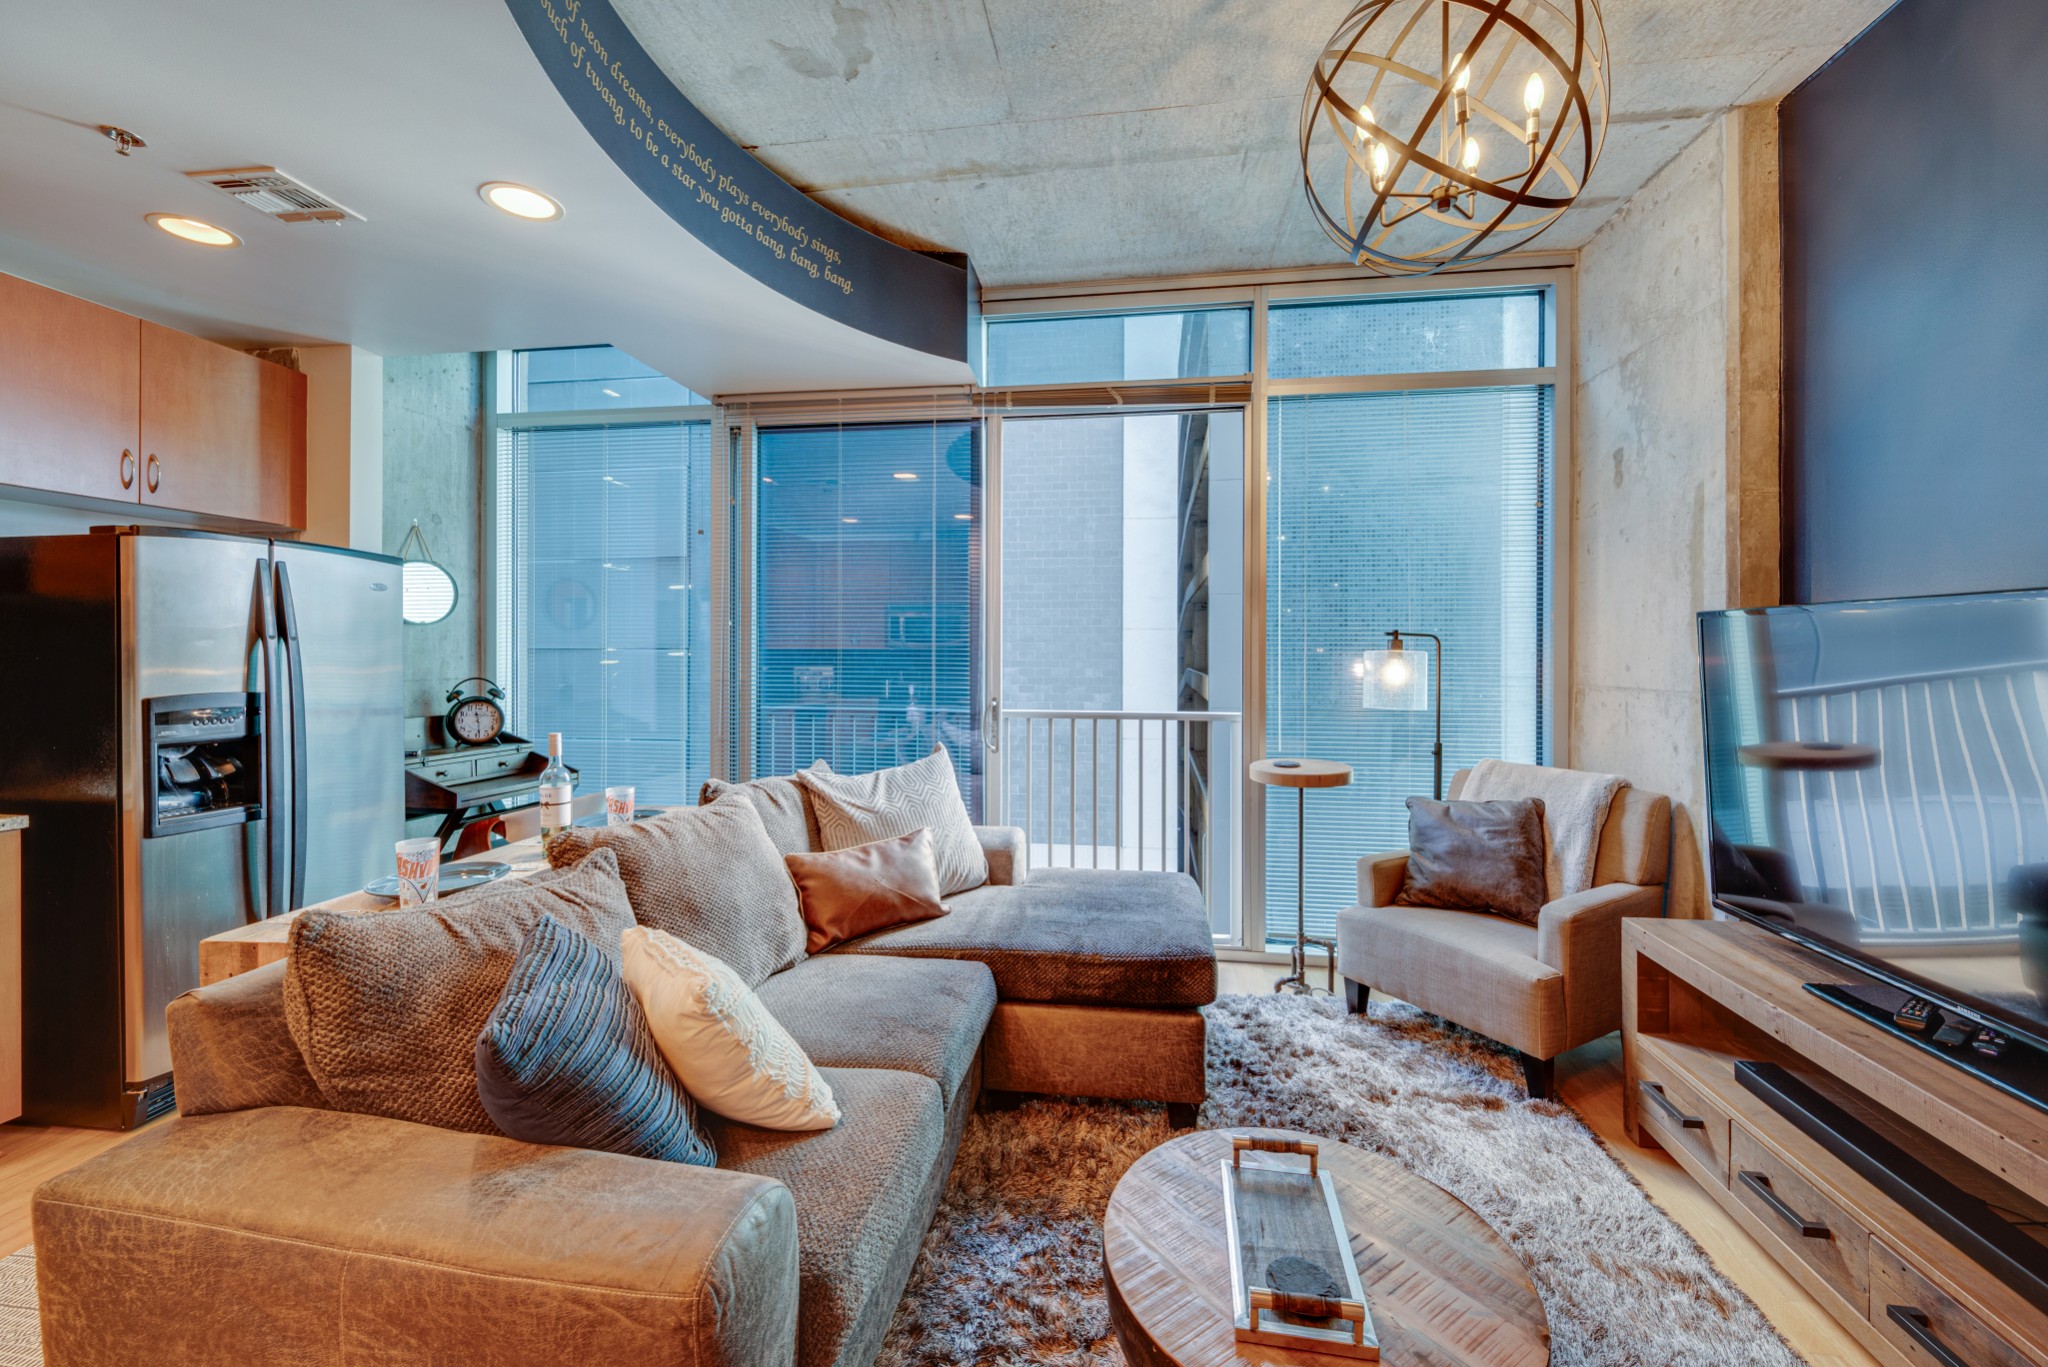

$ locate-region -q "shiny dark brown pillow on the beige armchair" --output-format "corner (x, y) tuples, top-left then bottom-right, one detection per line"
(1395, 797), (1544, 926)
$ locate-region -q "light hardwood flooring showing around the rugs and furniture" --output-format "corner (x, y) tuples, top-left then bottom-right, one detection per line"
(0, 963), (1878, 1367)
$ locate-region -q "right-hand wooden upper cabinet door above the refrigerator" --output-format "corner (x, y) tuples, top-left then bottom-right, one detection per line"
(137, 322), (305, 527)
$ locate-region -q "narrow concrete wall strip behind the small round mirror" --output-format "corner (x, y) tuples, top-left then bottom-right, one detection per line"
(381, 353), (485, 717)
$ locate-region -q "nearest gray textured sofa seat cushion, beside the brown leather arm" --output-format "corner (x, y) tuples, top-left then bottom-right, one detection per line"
(707, 1068), (946, 1367)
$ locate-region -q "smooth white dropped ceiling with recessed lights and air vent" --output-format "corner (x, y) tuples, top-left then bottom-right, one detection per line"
(0, 0), (971, 393)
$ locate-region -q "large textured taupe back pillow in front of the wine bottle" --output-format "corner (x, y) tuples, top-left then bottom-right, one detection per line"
(547, 795), (803, 988)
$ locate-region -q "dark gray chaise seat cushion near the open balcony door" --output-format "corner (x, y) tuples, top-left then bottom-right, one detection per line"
(823, 869), (1217, 1006)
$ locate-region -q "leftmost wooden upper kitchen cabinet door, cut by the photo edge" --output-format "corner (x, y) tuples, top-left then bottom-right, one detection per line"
(0, 275), (145, 502)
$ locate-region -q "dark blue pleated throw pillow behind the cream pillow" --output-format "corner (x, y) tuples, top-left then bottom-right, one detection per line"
(477, 916), (719, 1168)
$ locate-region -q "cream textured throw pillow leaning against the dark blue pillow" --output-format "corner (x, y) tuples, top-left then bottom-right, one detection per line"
(621, 926), (840, 1129)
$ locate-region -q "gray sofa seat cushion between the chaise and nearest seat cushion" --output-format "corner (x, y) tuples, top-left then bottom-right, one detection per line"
(760, 955), (995, 1107)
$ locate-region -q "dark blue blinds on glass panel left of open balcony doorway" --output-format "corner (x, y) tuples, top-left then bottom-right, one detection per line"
(754, 420), (981, 814)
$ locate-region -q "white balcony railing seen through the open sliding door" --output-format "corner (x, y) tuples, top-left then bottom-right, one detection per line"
(987, 707), (1243, 935)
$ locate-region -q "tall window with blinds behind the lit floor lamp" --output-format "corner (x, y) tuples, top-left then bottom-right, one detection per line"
(1264, 291), (1552, 943)
